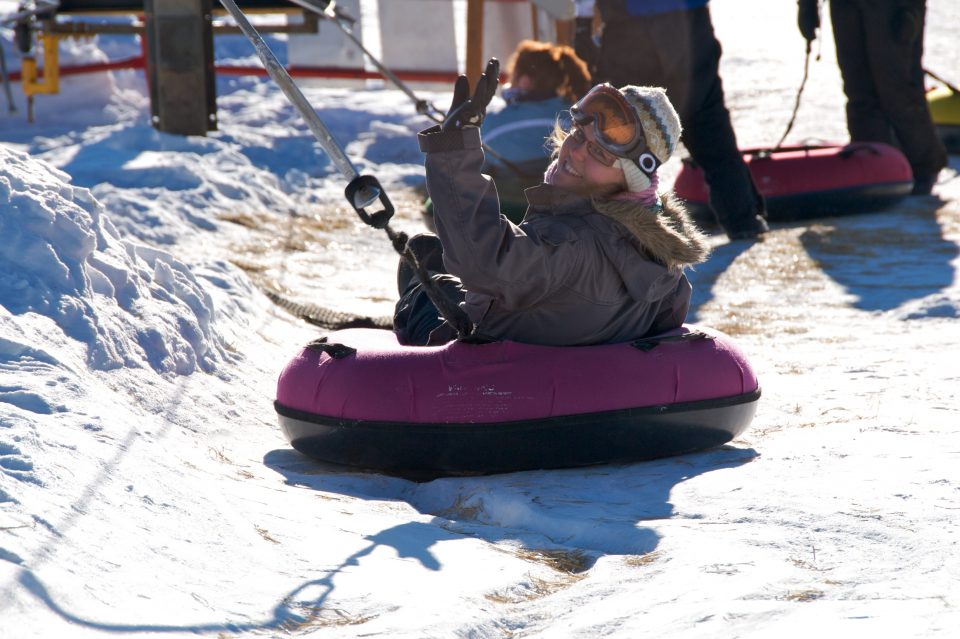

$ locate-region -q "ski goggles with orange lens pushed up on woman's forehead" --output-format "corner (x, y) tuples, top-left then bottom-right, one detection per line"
(570, 84), (661, 175)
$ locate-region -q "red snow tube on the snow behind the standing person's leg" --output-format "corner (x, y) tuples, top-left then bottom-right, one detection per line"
(673, 142), (913, 223)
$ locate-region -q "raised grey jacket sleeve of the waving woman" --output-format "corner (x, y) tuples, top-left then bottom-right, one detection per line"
(418, 127), (582, 309)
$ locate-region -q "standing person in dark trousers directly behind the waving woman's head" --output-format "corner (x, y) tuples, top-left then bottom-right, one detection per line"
(574, 0), (767, 239)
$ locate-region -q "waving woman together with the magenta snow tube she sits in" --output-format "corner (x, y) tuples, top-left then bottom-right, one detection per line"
(276, 69), (760, 477)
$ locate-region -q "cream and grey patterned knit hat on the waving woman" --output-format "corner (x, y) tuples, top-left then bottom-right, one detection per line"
(617, 85), (682, 192)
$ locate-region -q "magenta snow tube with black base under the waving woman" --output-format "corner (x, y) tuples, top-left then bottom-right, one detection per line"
(275, 326), (760, 477)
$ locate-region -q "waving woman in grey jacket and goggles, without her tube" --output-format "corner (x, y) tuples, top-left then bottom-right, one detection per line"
(394, 61), (708, 346)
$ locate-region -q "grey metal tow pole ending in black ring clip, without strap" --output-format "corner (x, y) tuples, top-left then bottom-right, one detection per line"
(220, 0), (393, 228)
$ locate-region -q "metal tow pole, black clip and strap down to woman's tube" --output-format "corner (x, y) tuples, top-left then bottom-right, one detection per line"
(220, 0), (473, 338)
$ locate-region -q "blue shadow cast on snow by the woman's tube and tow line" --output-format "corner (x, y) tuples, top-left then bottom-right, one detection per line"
(18, 446), (758, 634)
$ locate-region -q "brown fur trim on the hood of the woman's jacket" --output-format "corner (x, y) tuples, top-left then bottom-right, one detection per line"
(593, 195), (710, 270)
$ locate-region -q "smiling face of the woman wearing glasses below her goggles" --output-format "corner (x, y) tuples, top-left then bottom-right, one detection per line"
(552, 124), (627, 195)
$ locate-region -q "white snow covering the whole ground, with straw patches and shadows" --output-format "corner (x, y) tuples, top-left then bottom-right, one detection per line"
(0, 0), (960, 638)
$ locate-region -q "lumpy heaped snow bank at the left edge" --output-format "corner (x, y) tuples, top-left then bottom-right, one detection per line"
(0, 148), (227, 375)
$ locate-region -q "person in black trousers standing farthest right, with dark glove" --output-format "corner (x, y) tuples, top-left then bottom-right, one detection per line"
(797, 0), (947, 195)
